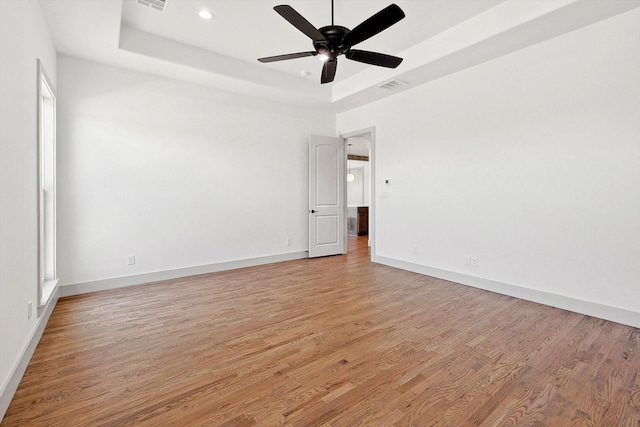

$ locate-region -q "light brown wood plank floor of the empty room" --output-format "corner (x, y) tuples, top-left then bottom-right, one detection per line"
(2, 237), (640, 427)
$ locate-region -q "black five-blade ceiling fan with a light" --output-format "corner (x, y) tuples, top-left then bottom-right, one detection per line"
(258, 0), (405, 83)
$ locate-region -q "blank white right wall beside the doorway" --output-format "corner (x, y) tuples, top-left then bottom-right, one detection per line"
(337, 10), (640, 326)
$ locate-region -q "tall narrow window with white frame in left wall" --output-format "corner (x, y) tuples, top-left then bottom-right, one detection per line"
(38, 60), (58, 308)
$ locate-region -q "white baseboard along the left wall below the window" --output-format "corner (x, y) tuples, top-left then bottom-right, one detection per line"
(0, 289), (59, 421)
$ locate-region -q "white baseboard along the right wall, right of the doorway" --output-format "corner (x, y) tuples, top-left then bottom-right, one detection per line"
(371, 255), (640, 328)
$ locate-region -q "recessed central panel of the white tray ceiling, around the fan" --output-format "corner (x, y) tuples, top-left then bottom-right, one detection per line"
(122, 0), (504, 83)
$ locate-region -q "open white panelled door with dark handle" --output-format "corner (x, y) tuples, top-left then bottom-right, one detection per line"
(309, 135), (347, 258)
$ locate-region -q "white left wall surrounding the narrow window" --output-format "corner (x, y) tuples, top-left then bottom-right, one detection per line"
(0, 0), (56, 419)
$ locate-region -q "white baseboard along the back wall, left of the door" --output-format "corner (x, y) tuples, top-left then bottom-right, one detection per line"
(59, 251), (309, 297)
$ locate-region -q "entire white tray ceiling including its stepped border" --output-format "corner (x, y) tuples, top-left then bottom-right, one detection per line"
(40, 0), (640, 111)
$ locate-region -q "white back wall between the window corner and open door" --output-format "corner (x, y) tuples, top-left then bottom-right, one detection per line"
(57, 56), (335, 285)
